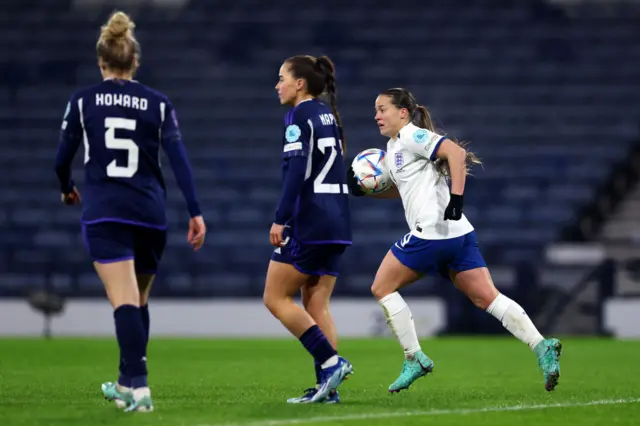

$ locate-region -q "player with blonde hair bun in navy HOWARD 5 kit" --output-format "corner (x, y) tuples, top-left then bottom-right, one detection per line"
(56, 12), (206, 411)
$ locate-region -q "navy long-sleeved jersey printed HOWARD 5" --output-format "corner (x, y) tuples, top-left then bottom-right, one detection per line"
(56, 79), (200, 228)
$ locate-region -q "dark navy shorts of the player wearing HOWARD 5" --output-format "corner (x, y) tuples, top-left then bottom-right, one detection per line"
(82, 222), (167, 274)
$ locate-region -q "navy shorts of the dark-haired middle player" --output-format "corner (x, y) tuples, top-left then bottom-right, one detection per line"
(271, 239), (348, 277)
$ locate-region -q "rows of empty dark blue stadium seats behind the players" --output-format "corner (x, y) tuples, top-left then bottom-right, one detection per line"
(0, 0), (640, 306)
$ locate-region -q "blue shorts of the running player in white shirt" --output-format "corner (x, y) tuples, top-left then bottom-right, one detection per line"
(391, 231), (487, 280)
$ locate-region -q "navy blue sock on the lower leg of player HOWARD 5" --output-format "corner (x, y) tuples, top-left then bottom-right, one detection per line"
(113, 305), (147, 388)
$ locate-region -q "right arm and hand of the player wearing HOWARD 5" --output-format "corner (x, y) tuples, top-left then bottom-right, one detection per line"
(160, 100), (207, 250)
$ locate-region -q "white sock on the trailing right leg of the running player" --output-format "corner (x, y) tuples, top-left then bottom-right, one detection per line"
(487, 294), (544, 350)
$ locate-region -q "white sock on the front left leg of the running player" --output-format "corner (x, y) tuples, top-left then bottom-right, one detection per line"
(379, 291), (420, 358)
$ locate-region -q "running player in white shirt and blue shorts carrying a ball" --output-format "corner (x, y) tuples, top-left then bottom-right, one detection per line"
(348, 88), (562, 392)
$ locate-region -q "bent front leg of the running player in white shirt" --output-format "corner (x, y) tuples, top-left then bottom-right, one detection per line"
(371, 236), (434, 392)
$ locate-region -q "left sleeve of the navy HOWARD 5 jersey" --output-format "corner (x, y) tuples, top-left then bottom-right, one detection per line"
(55, 96), (82, 196)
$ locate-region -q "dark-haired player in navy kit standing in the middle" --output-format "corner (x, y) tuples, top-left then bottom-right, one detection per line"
(264, 56), (353, 403)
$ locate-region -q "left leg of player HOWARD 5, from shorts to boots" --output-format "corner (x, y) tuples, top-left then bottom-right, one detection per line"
(83, 222), (153, 411)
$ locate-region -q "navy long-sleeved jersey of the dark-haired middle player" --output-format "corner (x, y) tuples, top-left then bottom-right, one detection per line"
(276, 99), (352, 244)
